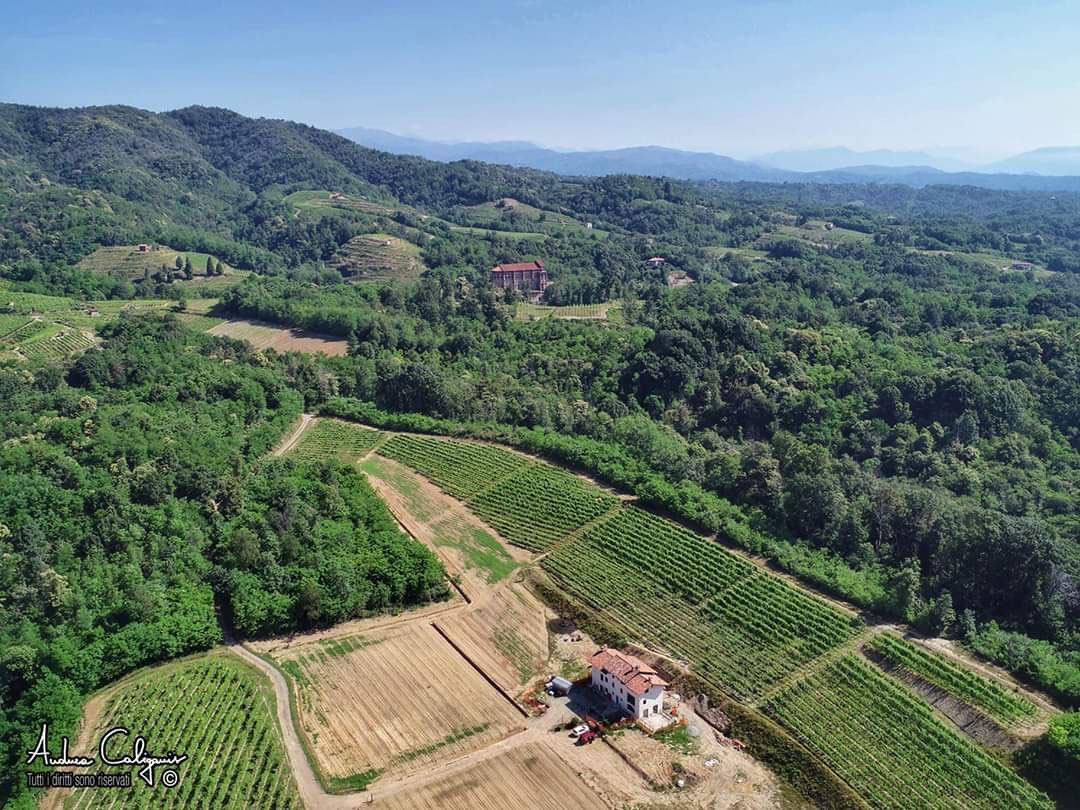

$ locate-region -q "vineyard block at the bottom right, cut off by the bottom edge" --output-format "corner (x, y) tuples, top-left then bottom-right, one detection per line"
(765, 656), (1054, 810)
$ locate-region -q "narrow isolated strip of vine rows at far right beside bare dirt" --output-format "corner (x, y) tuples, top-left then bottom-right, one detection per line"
(870, 633), (1037, 725)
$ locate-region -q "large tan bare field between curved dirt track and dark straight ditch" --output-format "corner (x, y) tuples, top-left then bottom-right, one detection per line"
(268, 623), (524, 786)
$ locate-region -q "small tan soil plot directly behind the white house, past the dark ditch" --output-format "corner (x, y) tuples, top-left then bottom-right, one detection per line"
(436, 582), (550, 694)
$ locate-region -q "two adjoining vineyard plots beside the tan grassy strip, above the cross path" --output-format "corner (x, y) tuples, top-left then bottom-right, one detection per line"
(379, 435), (619, 551)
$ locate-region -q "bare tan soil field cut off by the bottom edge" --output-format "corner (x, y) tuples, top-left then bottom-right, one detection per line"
(378, 742), (607, 810)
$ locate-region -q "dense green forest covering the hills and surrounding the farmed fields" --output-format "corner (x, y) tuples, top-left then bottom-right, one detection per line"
(6, 105), (1080, 807)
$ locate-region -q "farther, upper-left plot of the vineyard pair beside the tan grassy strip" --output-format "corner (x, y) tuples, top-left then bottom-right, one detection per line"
(379, 435), (529, 500)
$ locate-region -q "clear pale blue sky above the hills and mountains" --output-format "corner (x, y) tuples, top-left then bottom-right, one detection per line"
(0, 0), (1080, 159)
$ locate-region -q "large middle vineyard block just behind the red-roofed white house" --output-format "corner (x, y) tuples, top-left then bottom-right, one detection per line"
(541, 508), (854, 700)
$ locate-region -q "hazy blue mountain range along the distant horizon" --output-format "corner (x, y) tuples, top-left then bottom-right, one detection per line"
(338, 127), (1080, 191)
